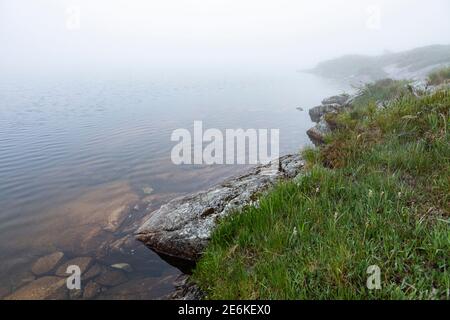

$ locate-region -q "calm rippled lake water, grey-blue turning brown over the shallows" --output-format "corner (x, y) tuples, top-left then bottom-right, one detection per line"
(0, 70), (348, 299)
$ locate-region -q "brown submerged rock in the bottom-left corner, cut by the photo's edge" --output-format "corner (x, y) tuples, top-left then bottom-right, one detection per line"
(5, 276), (68, 300)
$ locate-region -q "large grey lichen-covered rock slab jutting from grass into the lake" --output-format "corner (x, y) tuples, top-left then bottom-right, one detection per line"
(137, 155), (304, 261)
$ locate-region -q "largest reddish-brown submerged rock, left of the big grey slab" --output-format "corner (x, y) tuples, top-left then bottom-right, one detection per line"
(17, 182), (139, 256)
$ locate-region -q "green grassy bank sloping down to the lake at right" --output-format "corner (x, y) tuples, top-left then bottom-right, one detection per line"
(192, 86), (450, 299)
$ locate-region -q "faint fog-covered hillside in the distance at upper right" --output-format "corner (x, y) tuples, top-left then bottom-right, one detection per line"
(310, 45), (450, 82)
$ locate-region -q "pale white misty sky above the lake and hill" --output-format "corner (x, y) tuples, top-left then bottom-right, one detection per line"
(0, 0), (450, 71)
